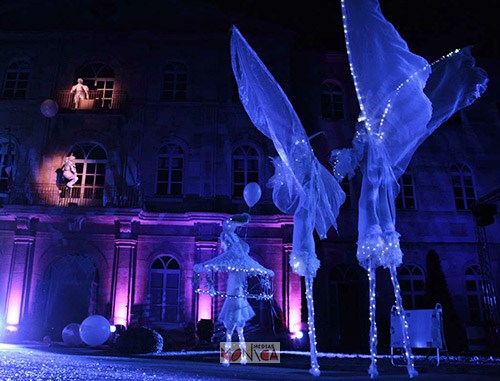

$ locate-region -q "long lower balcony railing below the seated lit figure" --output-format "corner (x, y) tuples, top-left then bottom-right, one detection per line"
(4, 183), (142, 208)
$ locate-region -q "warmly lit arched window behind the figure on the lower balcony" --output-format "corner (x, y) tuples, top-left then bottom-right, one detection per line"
(61, 143), (108, 206)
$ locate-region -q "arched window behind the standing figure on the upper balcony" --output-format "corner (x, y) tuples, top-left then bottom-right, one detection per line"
(75, 63), (115, 108)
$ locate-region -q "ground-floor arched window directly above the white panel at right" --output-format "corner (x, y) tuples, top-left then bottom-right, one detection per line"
(398, 265), (425, 310)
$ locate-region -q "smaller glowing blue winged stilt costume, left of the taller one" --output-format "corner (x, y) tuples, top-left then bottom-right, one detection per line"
(231, 26), (345, 376)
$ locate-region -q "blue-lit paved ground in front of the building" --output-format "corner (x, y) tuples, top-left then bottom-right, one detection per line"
(0, 343), (500, 381)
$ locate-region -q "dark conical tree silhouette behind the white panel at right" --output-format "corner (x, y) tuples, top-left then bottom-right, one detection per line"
(424, 250), (467, 354)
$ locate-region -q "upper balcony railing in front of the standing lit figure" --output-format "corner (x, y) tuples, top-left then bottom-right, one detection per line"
(53, 90), (127, 111)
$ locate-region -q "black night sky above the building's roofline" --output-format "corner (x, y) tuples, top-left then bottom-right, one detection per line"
(0, 0), (500, 59)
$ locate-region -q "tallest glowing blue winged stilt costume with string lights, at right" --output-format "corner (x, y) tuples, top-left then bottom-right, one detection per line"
(332, 0), (487, 378)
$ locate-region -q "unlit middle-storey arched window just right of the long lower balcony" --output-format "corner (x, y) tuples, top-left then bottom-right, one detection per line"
(156, 144), (184, 195)
